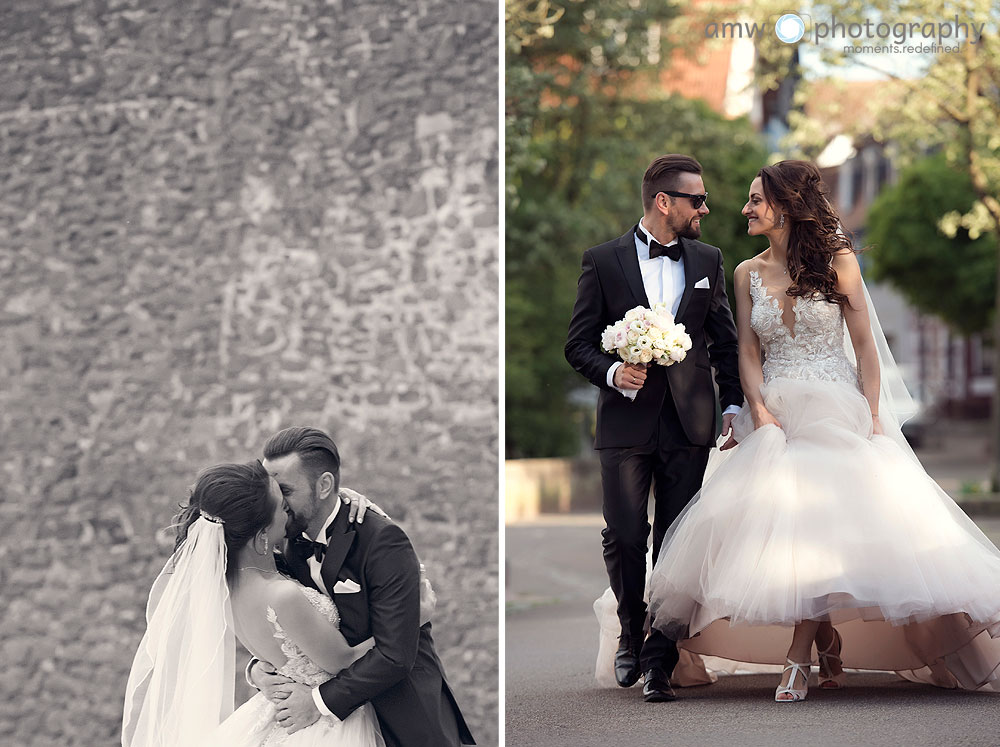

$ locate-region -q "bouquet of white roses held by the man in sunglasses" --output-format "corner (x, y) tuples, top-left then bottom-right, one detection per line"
(601, 303), (691, 366)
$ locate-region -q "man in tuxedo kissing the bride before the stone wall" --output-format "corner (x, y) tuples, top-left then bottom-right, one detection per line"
(247, 428), (475, 747)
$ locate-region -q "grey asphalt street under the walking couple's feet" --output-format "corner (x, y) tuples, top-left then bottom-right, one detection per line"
(505, 516), (1000, 747)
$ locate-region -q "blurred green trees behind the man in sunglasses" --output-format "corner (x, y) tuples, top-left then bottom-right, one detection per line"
(505, 0), (767, 457)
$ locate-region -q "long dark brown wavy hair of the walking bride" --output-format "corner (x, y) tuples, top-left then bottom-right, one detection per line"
(757, 161), (857, 306)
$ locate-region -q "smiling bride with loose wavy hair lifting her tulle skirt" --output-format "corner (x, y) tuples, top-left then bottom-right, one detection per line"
(600, 161), (1000, 702)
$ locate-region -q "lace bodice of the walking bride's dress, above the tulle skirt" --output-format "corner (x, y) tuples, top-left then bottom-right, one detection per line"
(750, 270), (858, 386)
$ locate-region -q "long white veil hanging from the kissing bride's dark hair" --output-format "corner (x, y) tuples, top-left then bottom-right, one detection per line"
(122, 515), (236, 747)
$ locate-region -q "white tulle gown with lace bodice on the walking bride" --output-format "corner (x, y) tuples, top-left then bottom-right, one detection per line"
(595, 271), (1000, 689)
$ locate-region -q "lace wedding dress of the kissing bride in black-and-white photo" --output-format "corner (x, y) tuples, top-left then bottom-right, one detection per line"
(213, 587), (385, 747)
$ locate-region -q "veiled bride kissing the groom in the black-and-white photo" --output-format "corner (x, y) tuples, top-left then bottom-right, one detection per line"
(122, 462), (426, 747)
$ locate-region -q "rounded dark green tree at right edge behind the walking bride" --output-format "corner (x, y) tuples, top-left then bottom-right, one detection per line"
(867, 154), (997, 335)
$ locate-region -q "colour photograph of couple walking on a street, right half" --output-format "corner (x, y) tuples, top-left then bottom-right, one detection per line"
(504, 0), (1000, 747)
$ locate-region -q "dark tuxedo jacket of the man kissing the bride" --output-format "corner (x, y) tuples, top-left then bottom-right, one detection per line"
(286, 506), (475, 747)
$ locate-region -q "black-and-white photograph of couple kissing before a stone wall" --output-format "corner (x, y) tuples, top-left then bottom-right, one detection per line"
(0, 0), (501, 747)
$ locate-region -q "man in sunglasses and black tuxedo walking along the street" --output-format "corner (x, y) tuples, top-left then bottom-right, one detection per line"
(565, 154), (743, 702)
